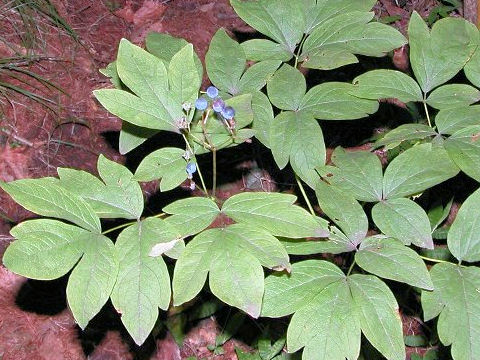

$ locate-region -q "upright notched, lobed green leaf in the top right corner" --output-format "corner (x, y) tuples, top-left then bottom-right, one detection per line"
(408, 11), (478, 93)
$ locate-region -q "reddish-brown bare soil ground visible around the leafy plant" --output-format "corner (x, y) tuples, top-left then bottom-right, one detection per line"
(0, 0), (472, 360)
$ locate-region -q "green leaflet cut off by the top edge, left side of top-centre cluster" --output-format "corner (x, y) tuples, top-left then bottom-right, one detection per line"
(230, 0), (305, 54)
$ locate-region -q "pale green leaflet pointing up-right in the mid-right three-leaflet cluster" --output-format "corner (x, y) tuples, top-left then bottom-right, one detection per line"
(383, 143), (459, 199)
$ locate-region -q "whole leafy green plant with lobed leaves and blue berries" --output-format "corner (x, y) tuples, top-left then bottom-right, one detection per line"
(1, 0), (480, 360)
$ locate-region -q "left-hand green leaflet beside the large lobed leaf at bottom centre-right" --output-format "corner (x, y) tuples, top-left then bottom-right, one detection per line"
(261, 260), (345, 318)
